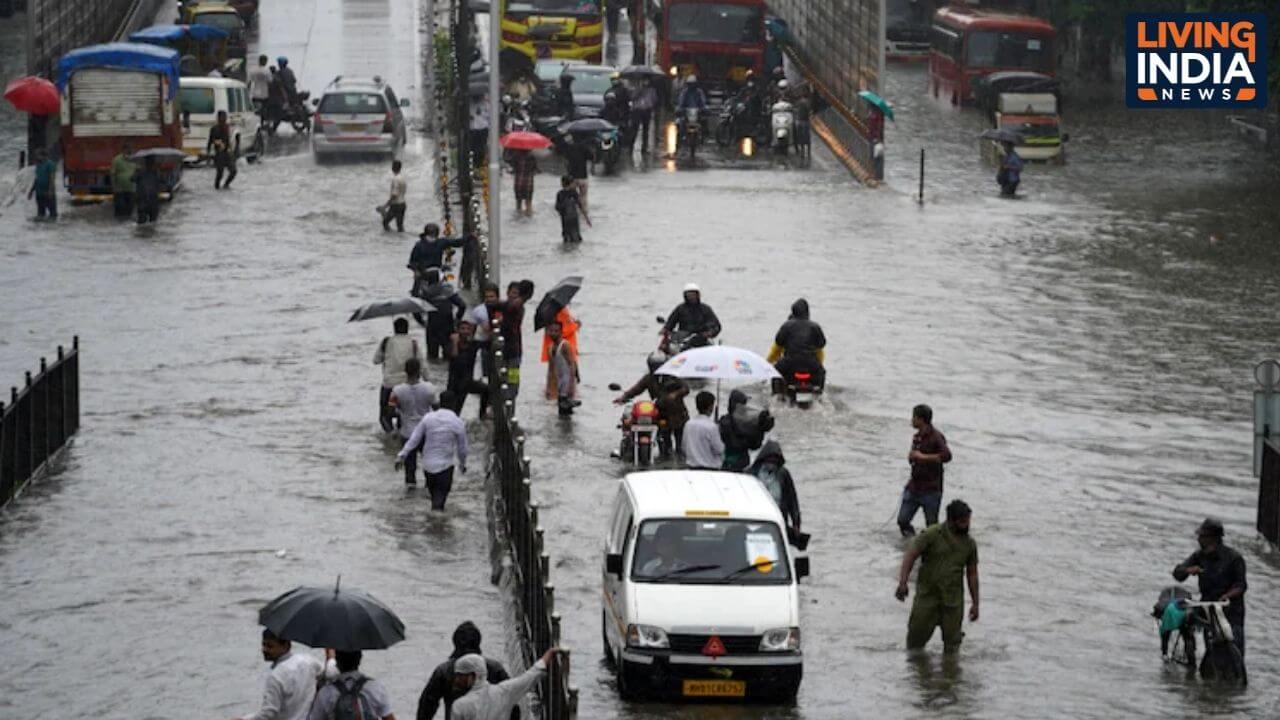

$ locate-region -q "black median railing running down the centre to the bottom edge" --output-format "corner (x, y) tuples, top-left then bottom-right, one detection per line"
(488, 323), (577, 720)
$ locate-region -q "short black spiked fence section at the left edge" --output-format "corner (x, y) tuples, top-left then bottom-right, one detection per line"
(0, 337), (79, 507)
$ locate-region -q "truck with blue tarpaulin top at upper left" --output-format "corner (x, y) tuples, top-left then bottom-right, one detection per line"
(58, 42), (182, 200)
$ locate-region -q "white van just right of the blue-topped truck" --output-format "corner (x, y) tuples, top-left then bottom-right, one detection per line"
(178, 76), (262, 163)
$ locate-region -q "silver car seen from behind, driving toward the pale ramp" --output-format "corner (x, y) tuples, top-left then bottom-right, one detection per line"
(311, 77), (408, 158)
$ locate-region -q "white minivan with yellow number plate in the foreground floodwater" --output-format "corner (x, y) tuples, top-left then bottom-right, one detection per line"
(602, 470), (809, 701)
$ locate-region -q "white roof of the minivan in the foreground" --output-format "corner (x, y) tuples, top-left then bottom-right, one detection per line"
(622, 470), (782, 517)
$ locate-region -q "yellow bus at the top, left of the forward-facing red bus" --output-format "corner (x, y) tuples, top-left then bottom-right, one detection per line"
(500, 0), (604, 64)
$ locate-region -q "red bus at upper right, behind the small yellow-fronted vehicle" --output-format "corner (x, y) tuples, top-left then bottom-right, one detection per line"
(929, 8), (1057, 105)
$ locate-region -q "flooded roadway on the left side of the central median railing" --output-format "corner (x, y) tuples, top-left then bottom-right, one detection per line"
(0, 0), (527, 720)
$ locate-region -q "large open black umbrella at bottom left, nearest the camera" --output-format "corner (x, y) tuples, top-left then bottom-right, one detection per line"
(257, 577), (404, 652)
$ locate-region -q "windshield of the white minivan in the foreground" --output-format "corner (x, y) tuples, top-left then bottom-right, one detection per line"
(631, 518), (791, 585)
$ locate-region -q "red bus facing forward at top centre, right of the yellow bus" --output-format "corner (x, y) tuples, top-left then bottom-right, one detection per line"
(655, 0), (767, 94)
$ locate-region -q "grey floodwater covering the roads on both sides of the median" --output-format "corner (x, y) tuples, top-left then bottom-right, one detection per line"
(0, 0), (1280, 719)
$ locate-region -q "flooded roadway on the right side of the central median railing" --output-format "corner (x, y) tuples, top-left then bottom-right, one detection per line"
(488, 68), (1280, 719)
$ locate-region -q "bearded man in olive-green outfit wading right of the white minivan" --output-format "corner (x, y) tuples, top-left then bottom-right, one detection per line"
(895, 500), (978, 652)
